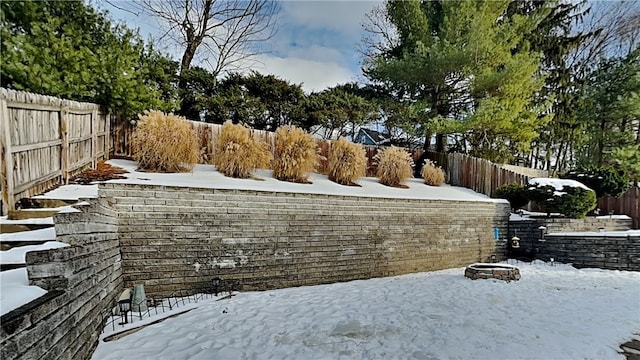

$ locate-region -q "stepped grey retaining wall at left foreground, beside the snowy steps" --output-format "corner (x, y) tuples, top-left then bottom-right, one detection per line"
(0, 201), (122, 360)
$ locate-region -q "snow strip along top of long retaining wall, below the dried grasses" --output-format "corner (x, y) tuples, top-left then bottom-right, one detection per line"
(108, 159), (507, 203)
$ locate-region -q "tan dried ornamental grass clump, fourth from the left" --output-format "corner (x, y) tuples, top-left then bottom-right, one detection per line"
(328, 137), (367, 185)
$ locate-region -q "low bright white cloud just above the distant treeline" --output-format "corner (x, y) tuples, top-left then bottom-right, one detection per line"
(254, 56), (355, 93)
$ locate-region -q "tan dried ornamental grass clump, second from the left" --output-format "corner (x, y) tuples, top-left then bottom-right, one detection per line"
(213, 121), (272, 179)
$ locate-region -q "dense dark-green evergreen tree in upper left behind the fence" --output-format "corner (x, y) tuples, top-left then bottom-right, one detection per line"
(0, 1), (176, 115)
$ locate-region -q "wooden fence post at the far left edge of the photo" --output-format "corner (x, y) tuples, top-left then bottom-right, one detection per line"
(0, 98), (15, 215)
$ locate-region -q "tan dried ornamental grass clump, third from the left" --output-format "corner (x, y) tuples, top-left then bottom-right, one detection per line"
(272, 126), (318, 183)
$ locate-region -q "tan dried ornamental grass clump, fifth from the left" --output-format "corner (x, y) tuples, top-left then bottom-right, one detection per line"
(375, 146), (413, 187)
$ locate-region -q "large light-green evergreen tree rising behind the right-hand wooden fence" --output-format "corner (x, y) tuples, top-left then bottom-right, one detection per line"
(365, 0), (544, 161)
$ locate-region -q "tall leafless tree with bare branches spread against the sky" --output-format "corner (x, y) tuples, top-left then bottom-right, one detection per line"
(137, 0), (280, 77)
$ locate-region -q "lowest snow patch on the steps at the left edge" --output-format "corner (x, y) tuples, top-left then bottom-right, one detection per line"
(0, 268), (47, 315)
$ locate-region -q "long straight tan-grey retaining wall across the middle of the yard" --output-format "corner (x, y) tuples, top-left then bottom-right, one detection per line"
(100, 184), (509, 296)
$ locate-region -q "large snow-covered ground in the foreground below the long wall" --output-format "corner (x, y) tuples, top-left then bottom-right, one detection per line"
(93, 262), (640, 360)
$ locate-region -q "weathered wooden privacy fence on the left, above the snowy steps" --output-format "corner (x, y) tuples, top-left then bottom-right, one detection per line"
(0, 88), (110, 215)
